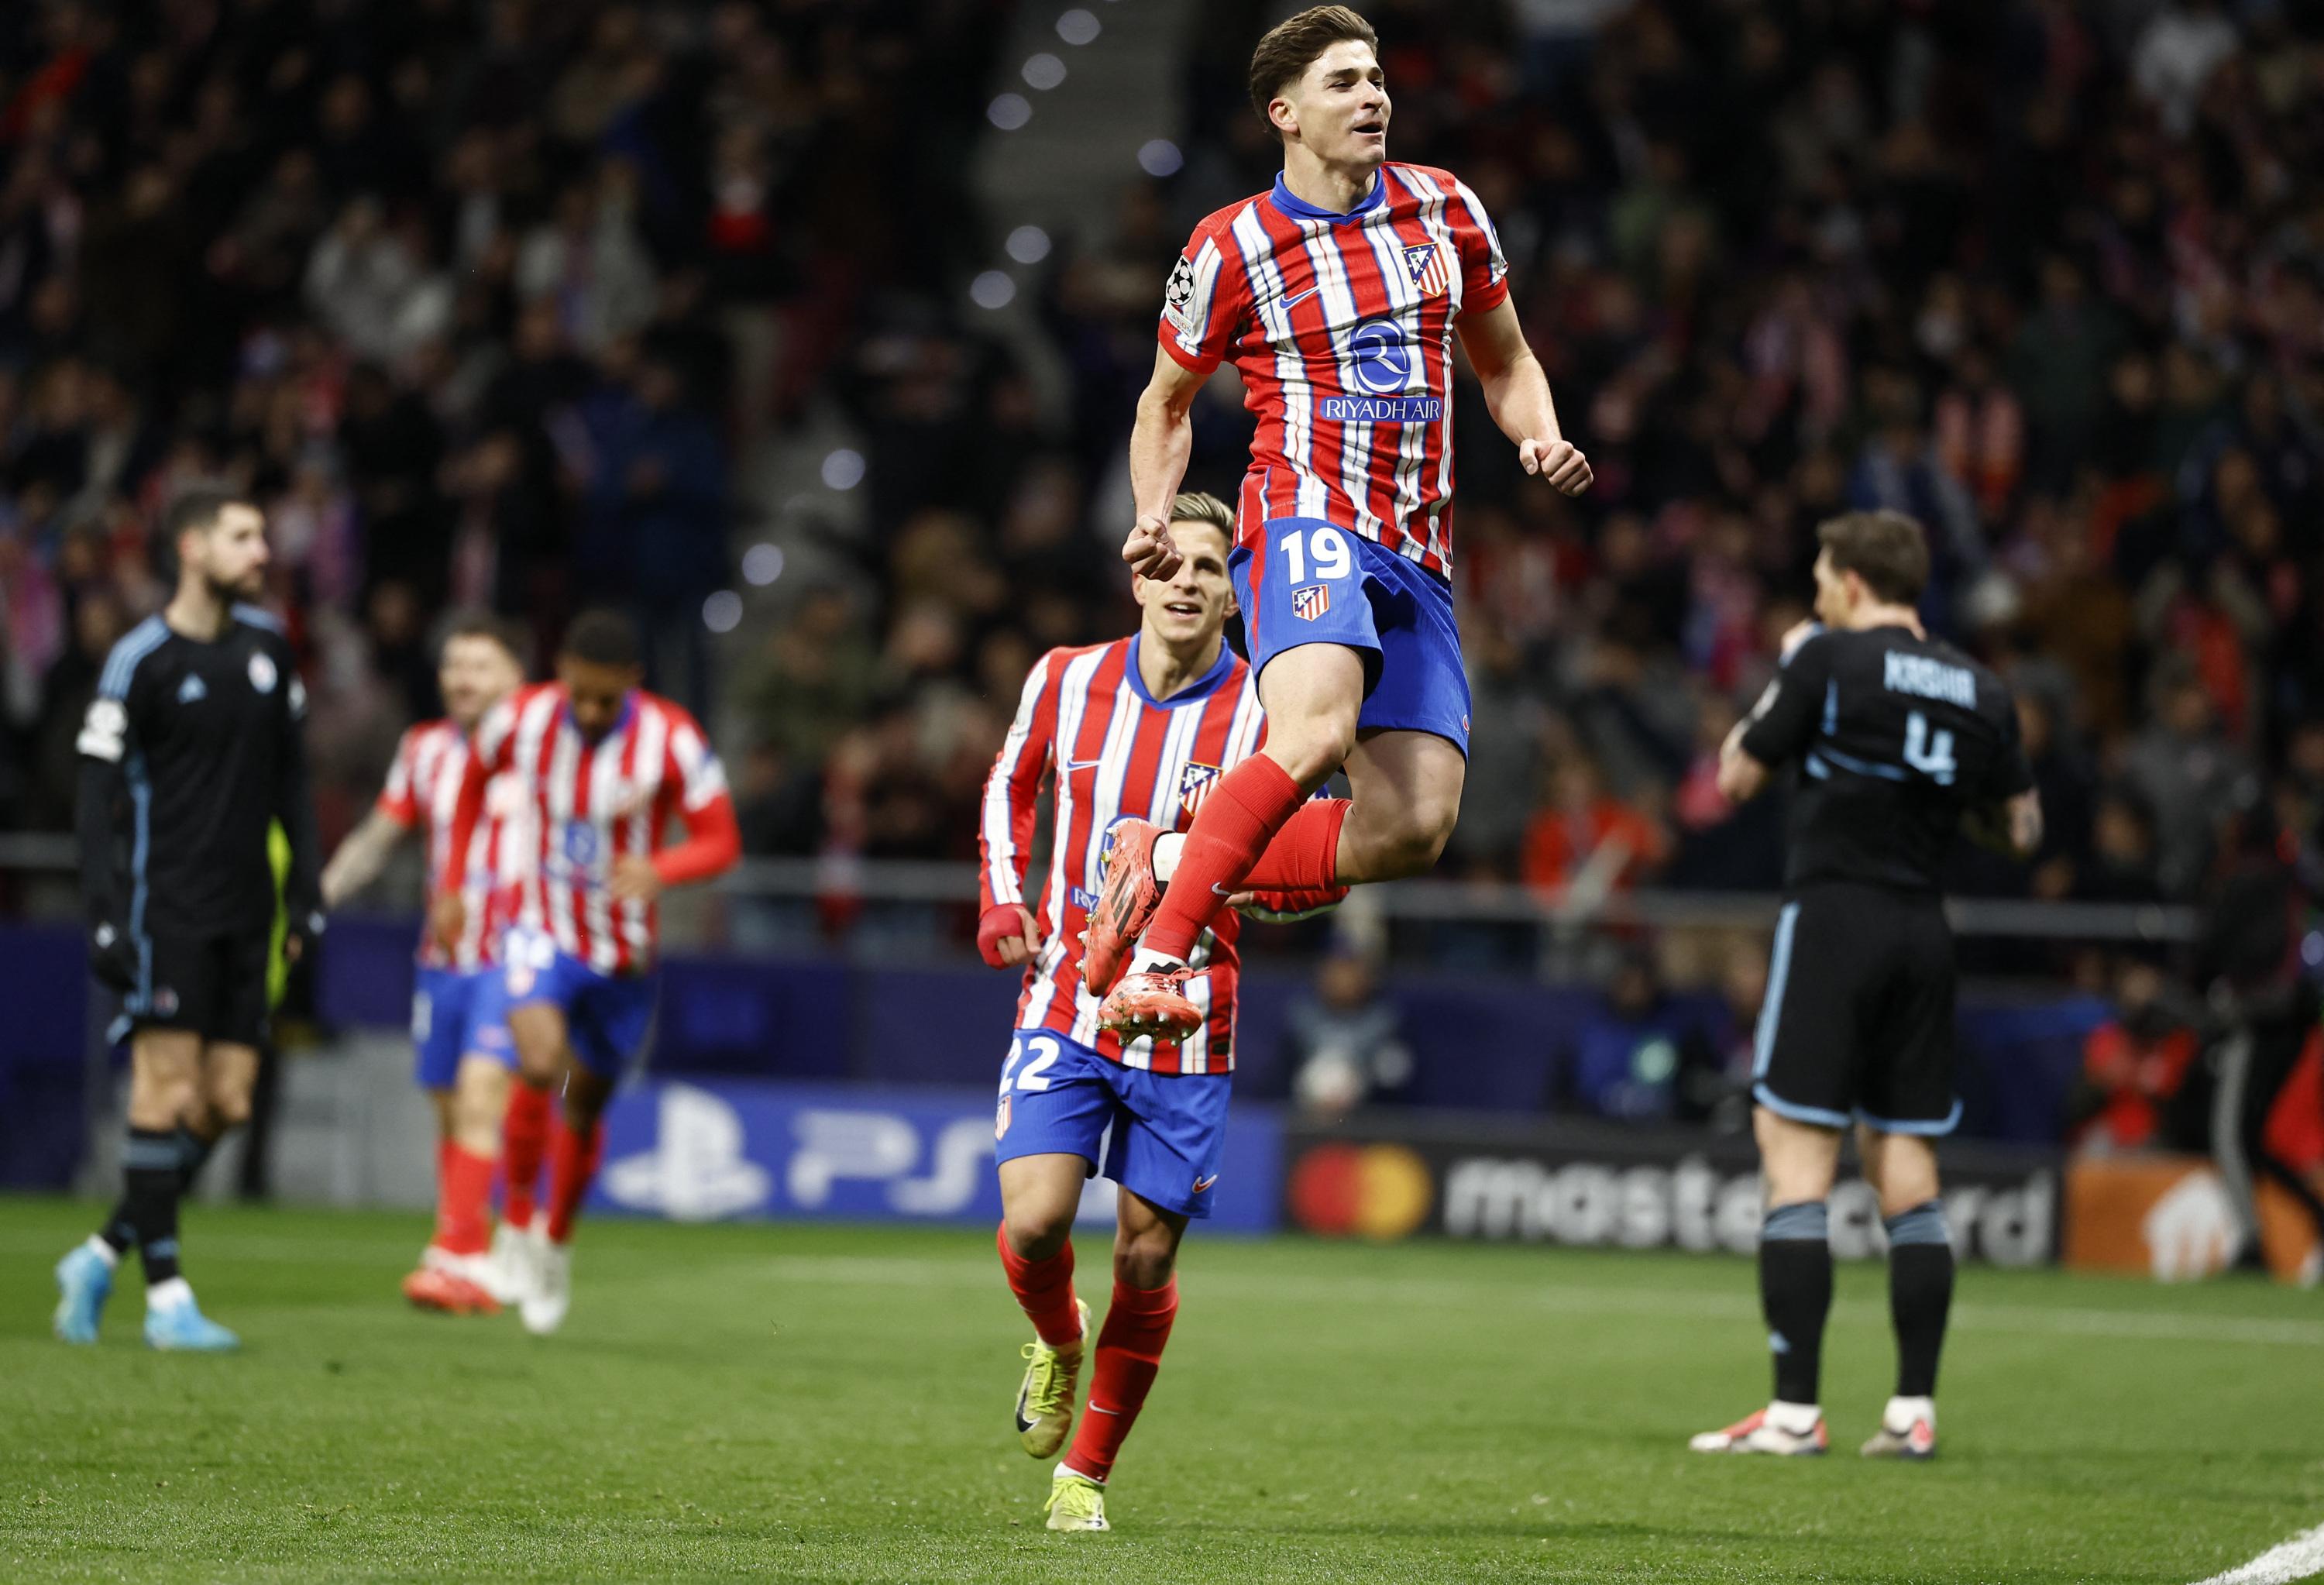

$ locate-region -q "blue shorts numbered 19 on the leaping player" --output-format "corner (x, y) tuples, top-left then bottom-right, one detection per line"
(1227, 518), (1469, 755)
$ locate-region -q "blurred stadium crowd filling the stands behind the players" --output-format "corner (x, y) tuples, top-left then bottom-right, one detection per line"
(0, 0), (2324, 958)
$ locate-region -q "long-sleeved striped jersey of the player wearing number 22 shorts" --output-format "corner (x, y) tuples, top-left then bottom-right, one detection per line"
(978, 637), (1264, 1074)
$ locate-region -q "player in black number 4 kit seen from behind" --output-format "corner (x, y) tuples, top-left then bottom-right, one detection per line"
(1692, 511), (2040, 1460)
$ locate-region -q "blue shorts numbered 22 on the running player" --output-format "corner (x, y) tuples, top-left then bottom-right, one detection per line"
(992, 1030), (1234, 1218)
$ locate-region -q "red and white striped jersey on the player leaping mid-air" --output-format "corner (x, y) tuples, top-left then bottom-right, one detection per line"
(1160, 163), (1508, 576)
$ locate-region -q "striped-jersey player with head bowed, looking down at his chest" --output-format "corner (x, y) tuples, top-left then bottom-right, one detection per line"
(432, 611), (741, 1332)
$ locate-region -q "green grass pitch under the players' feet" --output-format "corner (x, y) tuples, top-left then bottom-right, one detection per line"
(0, 1199), (2324, 1585)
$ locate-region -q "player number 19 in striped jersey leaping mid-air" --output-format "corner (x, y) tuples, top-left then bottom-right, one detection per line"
(1083, 5), (1590, 1039)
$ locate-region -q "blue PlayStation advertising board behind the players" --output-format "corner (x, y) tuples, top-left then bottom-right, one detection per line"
(590, 1078), (1283, 1232)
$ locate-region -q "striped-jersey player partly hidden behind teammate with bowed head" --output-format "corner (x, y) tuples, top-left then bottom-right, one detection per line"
(323, 616), (525, 1315)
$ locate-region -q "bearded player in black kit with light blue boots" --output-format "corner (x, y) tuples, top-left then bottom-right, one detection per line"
(56, 490), (323, 1348)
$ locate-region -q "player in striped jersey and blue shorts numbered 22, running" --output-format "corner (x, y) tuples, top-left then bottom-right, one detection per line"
(976, 495), (1346, 1532)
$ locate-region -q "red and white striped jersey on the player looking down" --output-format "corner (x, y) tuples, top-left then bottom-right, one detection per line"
(476, 683), (732, 974)
